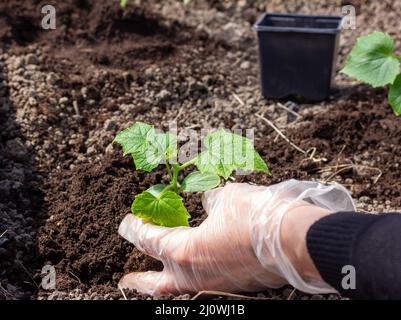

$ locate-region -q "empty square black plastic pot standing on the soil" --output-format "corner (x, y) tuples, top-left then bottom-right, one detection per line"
(254, 14), (342, 100)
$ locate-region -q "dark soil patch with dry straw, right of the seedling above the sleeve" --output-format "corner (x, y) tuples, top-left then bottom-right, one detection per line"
(252, 86), (401, 207)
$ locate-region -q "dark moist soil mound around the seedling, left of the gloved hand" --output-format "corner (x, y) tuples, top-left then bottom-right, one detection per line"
(39, 152), (203, 298)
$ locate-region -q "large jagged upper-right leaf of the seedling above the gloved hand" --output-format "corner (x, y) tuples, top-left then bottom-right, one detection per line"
(195, 129), (269, 179)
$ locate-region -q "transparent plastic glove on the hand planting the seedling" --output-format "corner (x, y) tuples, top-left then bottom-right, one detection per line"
(119, 180), (355, 296)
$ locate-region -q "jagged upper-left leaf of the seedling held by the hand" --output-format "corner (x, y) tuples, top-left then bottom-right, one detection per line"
(113, 122), (177, 172)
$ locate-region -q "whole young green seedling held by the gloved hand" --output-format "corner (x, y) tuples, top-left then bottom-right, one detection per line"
(113, 122), (269, 227)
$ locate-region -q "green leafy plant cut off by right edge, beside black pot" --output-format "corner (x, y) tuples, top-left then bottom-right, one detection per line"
(341, 32), (401, 116)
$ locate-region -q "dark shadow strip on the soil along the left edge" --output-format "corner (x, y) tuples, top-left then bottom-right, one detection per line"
(0, 65), (43, 300)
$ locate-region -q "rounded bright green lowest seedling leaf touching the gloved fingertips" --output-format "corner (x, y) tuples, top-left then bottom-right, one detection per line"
(131, 190), (190, 227)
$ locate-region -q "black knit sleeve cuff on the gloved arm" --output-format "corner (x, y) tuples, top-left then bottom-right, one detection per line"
(306, 212), (401, 299)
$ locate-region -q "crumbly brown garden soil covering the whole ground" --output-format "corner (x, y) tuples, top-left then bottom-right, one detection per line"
(0, 0), (401, 299)
